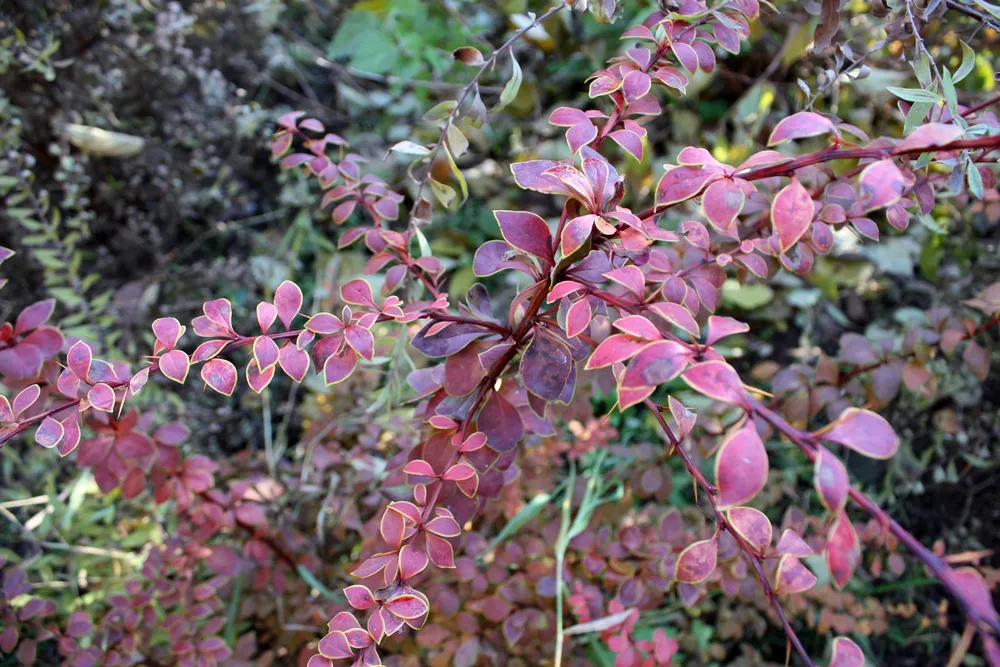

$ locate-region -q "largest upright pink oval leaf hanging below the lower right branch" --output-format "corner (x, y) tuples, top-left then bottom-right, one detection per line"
(715, 419), (769, 508)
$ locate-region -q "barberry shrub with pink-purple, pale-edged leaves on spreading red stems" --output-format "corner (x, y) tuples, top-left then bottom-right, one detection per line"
(0, 0), (1000, 667)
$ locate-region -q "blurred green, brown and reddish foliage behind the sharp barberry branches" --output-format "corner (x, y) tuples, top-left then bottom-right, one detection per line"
(0, 0), (1000, 665)
